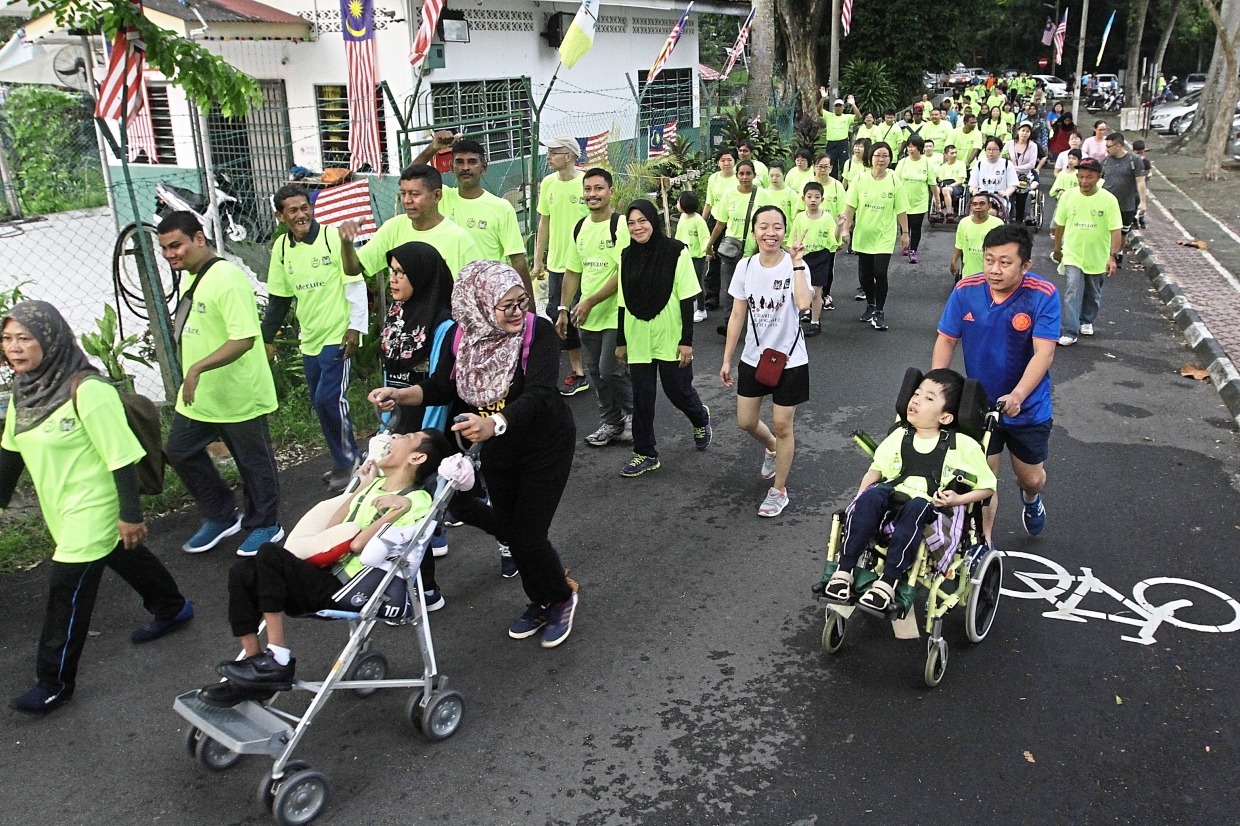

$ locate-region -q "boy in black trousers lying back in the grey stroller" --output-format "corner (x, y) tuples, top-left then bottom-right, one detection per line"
(198, 429), (453, 707)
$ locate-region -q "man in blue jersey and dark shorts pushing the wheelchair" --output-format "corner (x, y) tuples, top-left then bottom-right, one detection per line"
(931, 224), (1059, 546)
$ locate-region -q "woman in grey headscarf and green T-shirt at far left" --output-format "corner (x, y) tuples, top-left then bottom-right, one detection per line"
(0, 301), (193, 714)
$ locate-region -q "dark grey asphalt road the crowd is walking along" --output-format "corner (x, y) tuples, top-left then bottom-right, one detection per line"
(0, 209), (1240, 826)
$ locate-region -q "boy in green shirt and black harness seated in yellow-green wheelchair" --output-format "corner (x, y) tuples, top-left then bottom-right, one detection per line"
(823, 368), (997, 615)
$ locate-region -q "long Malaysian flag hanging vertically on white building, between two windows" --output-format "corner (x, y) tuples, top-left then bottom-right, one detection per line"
(340, 0), (383, 172)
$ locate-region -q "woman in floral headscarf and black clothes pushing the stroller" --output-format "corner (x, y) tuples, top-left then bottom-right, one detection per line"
(370, 260), (577, 649)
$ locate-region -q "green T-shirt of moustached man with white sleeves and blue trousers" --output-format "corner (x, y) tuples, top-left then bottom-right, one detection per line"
(267, 223), (362, 356)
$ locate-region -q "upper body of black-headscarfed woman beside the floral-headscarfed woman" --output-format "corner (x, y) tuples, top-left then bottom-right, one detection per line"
(379, 241), (453, 433)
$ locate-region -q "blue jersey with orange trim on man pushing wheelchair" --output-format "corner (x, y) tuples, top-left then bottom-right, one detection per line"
(939, 273), (1059, 427)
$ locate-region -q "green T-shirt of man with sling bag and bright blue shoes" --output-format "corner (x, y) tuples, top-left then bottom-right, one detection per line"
(176, 260), (275, 422)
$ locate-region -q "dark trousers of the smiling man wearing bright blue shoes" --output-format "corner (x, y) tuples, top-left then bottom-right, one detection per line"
(164, 409), (280, 531)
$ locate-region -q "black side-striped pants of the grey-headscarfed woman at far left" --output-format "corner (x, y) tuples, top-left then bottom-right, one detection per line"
(36, 542), (185, 695)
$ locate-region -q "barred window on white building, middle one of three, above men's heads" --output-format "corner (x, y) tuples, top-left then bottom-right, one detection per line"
(424, 78), (533, 161)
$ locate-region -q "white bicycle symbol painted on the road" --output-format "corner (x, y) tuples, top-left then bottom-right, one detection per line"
(999, 551), (1240, 645)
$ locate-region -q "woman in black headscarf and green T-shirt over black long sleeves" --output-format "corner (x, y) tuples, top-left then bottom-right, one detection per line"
(616, 200), (711, 476)
